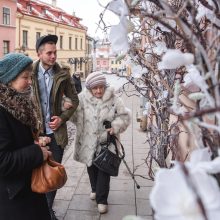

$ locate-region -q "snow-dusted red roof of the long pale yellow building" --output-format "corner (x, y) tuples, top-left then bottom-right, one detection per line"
(17, 0), (87, 30)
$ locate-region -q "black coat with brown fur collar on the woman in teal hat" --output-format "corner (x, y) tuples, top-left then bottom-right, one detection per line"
(0, 84), (50, 220)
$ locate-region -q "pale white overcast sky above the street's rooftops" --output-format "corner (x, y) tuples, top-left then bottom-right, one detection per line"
(41, 0), (118, 38)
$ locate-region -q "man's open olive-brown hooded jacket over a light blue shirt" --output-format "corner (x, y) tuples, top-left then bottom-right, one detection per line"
(32, 60), (79, 147)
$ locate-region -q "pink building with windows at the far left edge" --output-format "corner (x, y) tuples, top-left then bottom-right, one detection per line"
(0, 0), (17, 57)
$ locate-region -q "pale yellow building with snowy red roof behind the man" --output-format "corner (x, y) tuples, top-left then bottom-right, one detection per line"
(16, 0), (88, 78)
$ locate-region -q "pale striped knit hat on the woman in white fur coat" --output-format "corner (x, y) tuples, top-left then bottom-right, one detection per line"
(85, 72), (107, 89)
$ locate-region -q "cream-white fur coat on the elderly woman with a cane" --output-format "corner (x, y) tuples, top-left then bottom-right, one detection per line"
(71, 87), (131, 166)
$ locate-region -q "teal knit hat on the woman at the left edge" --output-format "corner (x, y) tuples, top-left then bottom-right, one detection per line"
(0, 53), (33, 84)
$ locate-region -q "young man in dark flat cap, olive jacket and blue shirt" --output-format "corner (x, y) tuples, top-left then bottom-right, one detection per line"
(33, 35), (79, 220)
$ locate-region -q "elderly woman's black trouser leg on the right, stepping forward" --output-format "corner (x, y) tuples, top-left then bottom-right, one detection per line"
(96, 170), (110, 205)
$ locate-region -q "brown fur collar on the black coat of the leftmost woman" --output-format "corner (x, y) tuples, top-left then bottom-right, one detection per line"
(0, 84), (38, 130)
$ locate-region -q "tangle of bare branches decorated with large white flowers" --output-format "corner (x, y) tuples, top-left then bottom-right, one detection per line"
(99, 0), (220, 220)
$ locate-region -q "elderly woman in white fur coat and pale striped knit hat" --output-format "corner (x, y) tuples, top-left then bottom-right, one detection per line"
(72, 72), (130, 213)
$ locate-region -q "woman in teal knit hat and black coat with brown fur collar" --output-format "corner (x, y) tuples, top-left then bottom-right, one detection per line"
(0, 53), (51, 220)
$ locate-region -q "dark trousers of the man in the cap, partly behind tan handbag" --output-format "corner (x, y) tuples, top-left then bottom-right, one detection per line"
(46, 134), (64, 210)
